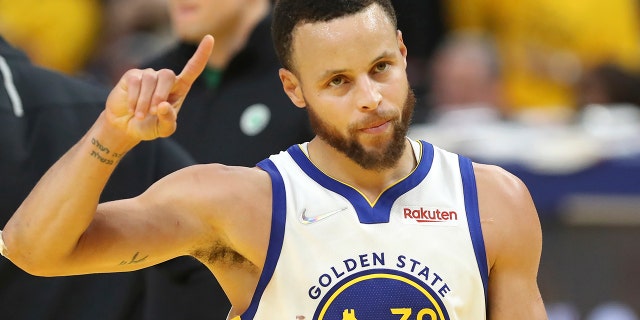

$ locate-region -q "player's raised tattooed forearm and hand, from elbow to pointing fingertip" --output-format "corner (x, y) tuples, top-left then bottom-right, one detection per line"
(2, 36), (213, 275)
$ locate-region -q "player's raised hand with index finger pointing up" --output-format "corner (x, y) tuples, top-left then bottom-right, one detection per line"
(105, 35), (214, 140)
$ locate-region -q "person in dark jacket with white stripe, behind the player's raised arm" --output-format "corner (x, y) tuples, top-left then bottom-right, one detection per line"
(0, 36), (194, 320)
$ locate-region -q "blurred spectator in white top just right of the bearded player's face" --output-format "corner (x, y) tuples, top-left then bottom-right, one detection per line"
(410, 31), (513, 164)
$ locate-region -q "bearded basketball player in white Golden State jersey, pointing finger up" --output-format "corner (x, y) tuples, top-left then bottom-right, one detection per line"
(0, 0), (546, 320)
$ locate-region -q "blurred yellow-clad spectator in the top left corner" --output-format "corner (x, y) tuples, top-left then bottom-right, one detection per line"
(0, 0), (102, 74)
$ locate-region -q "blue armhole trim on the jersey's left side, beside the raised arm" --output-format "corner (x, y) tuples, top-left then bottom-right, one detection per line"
(241, 159), (287, 320)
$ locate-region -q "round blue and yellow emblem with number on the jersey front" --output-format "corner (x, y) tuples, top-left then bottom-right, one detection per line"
(313, 269), (449, 320)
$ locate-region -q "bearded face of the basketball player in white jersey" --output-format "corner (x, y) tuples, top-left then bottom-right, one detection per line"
(292, 5), (415, 170)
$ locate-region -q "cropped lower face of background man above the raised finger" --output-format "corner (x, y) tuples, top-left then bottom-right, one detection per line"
(169, 0), (247, 43)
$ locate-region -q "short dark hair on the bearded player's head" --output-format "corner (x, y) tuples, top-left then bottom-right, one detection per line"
(271, 0), (398, 70)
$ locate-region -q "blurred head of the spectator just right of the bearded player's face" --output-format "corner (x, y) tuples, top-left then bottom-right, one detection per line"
(427, 33), (504, 125)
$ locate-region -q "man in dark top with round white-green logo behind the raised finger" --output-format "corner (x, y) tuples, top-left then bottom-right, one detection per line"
(145, 0), (313, 166)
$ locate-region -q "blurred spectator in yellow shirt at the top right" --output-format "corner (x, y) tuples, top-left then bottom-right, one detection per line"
(446, 0), (640, 119)
